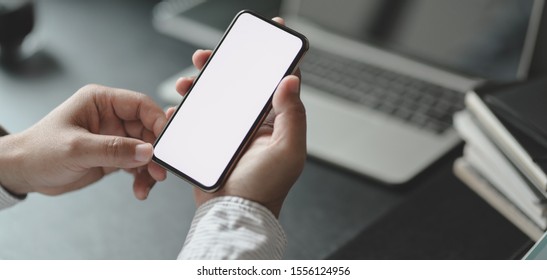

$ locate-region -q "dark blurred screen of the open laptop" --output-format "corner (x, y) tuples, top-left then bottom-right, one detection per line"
(291, 0), (535, 80)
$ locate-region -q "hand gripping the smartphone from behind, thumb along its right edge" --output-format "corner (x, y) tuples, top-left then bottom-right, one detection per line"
(172, 18), (306, 217)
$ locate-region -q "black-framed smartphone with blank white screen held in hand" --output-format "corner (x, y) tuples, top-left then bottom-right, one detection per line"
(153, 10), (308, 192)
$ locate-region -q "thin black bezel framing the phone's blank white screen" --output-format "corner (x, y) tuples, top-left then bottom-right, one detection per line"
(152, 10), (309, 192)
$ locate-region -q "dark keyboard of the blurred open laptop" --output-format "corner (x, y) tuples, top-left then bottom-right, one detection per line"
(300, 49), (464, 134)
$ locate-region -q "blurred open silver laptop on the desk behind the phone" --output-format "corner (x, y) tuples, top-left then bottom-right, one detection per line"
(155, 0), (544, 185)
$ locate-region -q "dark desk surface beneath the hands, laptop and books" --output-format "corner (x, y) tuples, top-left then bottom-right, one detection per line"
(0, 0), (530, 259)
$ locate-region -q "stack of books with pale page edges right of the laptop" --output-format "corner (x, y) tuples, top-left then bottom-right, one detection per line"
(454, 79), (547, 240)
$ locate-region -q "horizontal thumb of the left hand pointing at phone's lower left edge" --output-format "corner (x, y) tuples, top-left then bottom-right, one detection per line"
(77, 134), (153, 168)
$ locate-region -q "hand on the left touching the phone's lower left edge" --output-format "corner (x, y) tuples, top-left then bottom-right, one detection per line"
(0, 85), (167, 199)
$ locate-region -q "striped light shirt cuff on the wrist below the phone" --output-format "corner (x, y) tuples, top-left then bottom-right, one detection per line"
(178, 196), (287, 259)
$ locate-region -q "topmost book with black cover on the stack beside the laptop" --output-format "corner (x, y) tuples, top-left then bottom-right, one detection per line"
(465, 80), (547, 194)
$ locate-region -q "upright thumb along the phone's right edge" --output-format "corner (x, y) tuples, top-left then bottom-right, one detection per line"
(272, 75), (306, 151)
